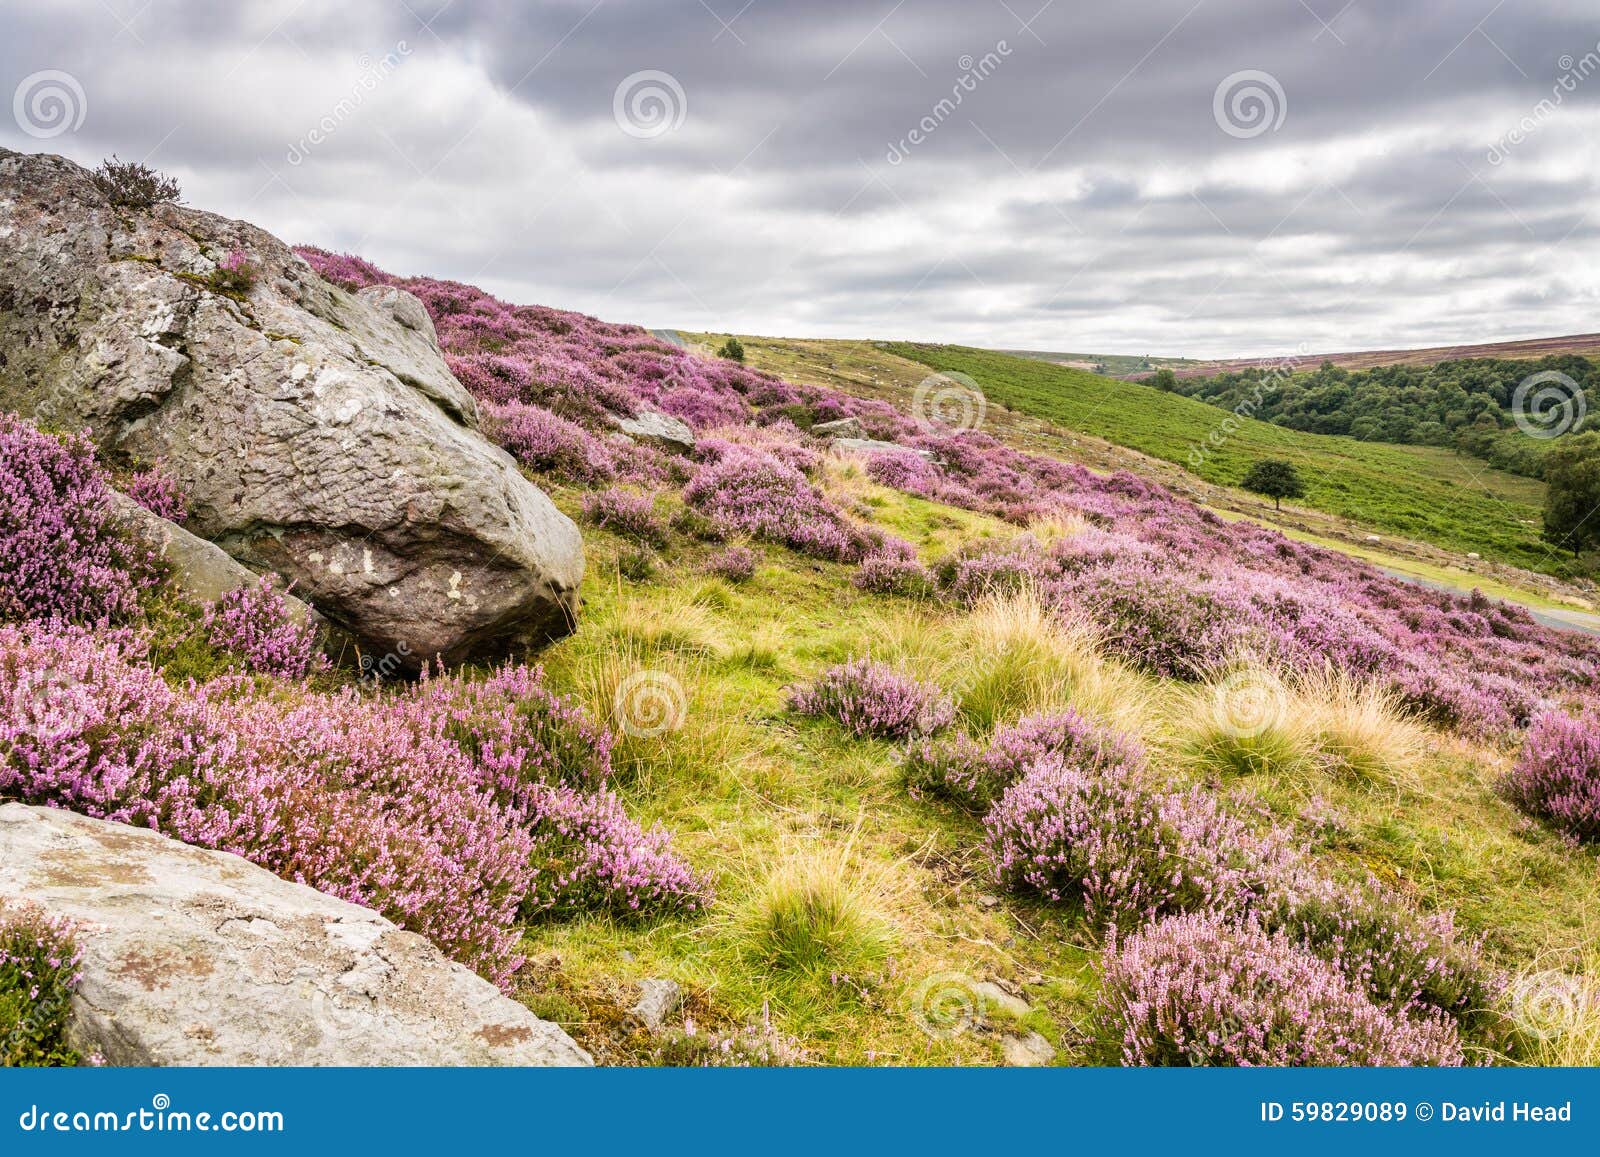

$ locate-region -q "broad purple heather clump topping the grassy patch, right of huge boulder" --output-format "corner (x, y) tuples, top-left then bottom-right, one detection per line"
(683, 446), (875, 562)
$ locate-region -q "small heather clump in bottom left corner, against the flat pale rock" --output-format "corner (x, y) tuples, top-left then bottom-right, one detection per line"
(0, 904), (83, 1067)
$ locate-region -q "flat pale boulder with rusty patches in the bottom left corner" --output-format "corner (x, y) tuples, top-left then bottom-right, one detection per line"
(0, 803), (590, 1066)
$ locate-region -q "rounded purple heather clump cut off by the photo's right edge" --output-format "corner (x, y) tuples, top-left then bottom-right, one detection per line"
(1502, 711), (1600, 843)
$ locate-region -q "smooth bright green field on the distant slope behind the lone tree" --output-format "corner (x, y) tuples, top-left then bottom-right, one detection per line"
(880, 342), (1566, 573)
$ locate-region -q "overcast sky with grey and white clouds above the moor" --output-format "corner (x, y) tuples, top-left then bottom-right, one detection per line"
(0, 0), (1600, 357)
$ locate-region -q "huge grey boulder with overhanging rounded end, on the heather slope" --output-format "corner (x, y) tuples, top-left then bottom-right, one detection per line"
(0, 149), (582, 667)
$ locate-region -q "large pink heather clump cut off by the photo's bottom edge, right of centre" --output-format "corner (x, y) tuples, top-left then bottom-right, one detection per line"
(1096, 915), (1466, 1066)
